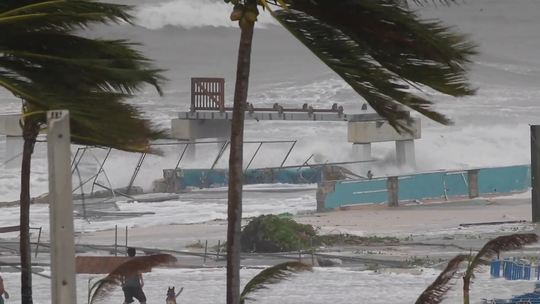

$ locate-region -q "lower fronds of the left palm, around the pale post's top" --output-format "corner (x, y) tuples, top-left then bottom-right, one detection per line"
(12, 80), (169, 155)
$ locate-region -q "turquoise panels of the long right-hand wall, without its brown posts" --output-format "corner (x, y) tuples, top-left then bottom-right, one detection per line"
(324, 166), (531, 210)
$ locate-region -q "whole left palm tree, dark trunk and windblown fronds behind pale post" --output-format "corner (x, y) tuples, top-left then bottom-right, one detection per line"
(0, 0), (166, 304)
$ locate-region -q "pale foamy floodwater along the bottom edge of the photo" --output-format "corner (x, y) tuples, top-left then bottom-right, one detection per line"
(2, 268), (534, 304)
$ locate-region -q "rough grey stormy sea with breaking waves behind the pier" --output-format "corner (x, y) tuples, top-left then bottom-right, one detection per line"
(0, 0), (540, 199)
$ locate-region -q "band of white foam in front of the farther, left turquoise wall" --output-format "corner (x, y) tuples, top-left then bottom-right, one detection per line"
(0, 192), (315, 236)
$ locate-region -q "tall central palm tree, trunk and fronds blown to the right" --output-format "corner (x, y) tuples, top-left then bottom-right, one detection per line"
(225, 0), (477, 304)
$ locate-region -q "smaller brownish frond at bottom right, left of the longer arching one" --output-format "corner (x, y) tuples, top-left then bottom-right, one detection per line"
(415, 254), (469, 304)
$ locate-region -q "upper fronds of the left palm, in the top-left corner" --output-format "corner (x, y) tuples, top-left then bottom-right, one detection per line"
(0, 0), (166, 95)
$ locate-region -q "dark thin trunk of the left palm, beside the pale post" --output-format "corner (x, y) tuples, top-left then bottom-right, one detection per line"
(19, 125), (38, 304)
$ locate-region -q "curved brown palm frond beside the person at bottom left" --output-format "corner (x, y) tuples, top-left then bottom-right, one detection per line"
(88, 254), (176, 304)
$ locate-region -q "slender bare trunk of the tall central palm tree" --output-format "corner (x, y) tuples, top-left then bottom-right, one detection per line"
(227, 11), (254, 304)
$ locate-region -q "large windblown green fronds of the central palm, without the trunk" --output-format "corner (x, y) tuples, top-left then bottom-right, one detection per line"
(273, 0), (476, 131)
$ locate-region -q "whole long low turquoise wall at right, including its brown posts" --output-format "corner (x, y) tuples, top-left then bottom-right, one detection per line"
(317, 165), (531, 212)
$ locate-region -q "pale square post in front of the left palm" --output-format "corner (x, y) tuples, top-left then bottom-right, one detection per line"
(47, 110), (77, 304)
